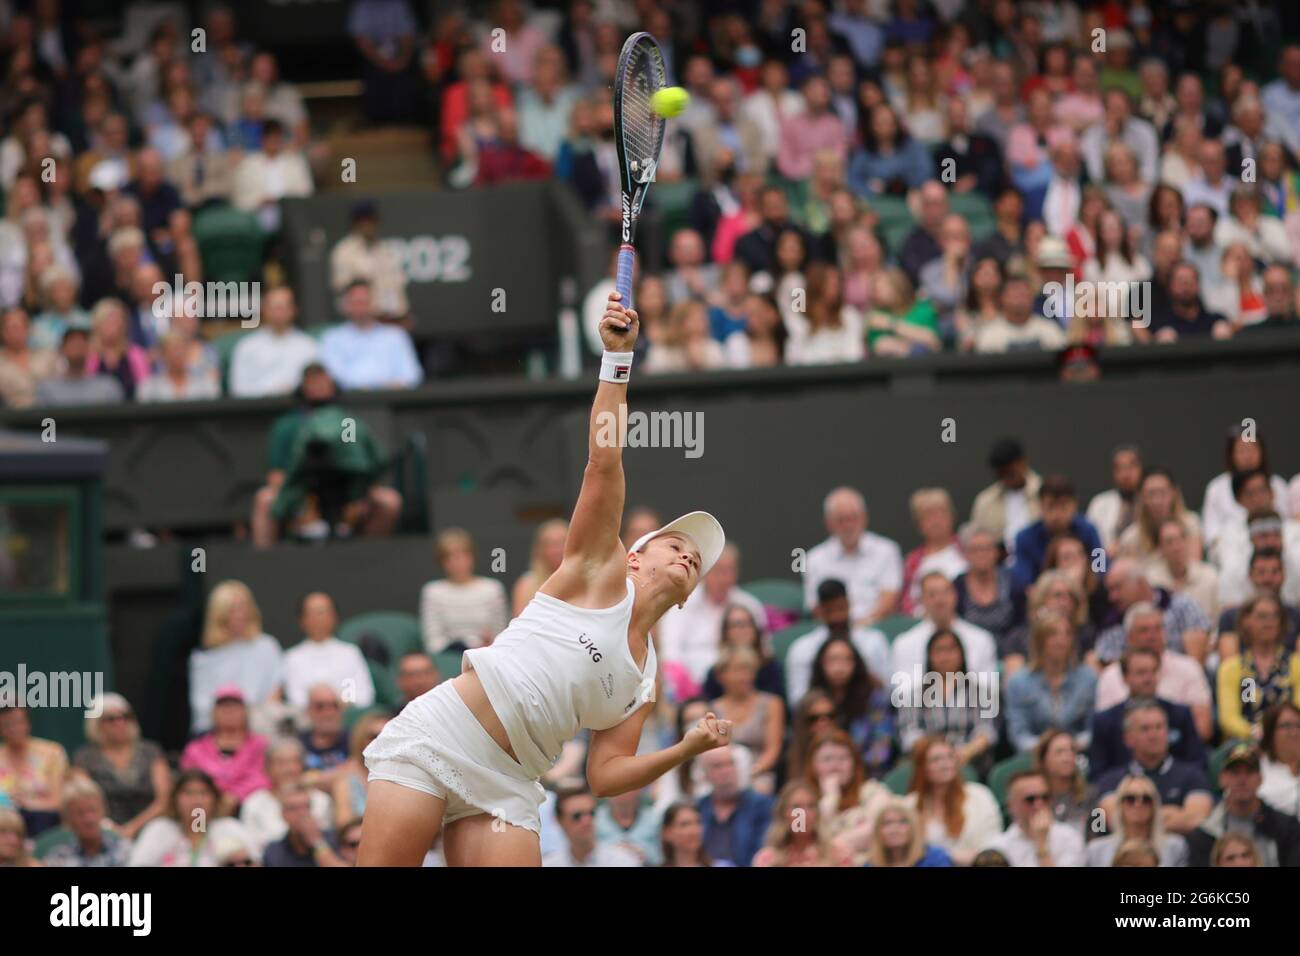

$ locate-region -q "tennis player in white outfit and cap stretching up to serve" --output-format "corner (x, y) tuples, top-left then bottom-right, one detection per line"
(358, 291), (731, 866)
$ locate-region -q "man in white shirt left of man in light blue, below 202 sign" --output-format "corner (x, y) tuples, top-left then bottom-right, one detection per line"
(230, 286), (320, 398)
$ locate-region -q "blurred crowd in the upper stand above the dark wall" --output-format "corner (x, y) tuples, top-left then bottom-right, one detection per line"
(0, 0), (1300, 407)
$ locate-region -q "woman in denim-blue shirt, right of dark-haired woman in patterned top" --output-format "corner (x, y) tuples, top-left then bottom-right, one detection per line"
(1006, 611), (1097, 752)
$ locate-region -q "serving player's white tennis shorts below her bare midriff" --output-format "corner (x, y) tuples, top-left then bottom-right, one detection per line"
(363, 680), (546, 834)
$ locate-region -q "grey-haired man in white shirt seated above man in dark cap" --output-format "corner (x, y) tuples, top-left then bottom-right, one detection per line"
(803, 488), (902, 626)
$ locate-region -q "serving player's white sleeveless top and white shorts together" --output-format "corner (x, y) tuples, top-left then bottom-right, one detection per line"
(364, 578), (657, 831)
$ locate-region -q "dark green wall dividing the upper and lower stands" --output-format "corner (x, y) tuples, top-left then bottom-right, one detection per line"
(0, 333), (1300, 579)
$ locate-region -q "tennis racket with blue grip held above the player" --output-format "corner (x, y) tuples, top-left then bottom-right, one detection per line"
(614, 33), (668, 329)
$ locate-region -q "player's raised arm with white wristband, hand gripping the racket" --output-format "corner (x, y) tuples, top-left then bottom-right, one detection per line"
(564, 291), (640, 581)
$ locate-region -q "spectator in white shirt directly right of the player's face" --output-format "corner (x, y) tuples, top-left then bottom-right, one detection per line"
(657, 544), (767, 684)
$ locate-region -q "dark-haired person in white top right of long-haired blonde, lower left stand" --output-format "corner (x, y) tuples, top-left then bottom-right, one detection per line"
(282, 591), (374, 710)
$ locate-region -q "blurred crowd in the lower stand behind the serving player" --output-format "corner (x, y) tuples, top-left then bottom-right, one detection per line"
(0, 425), (1300, 866)
